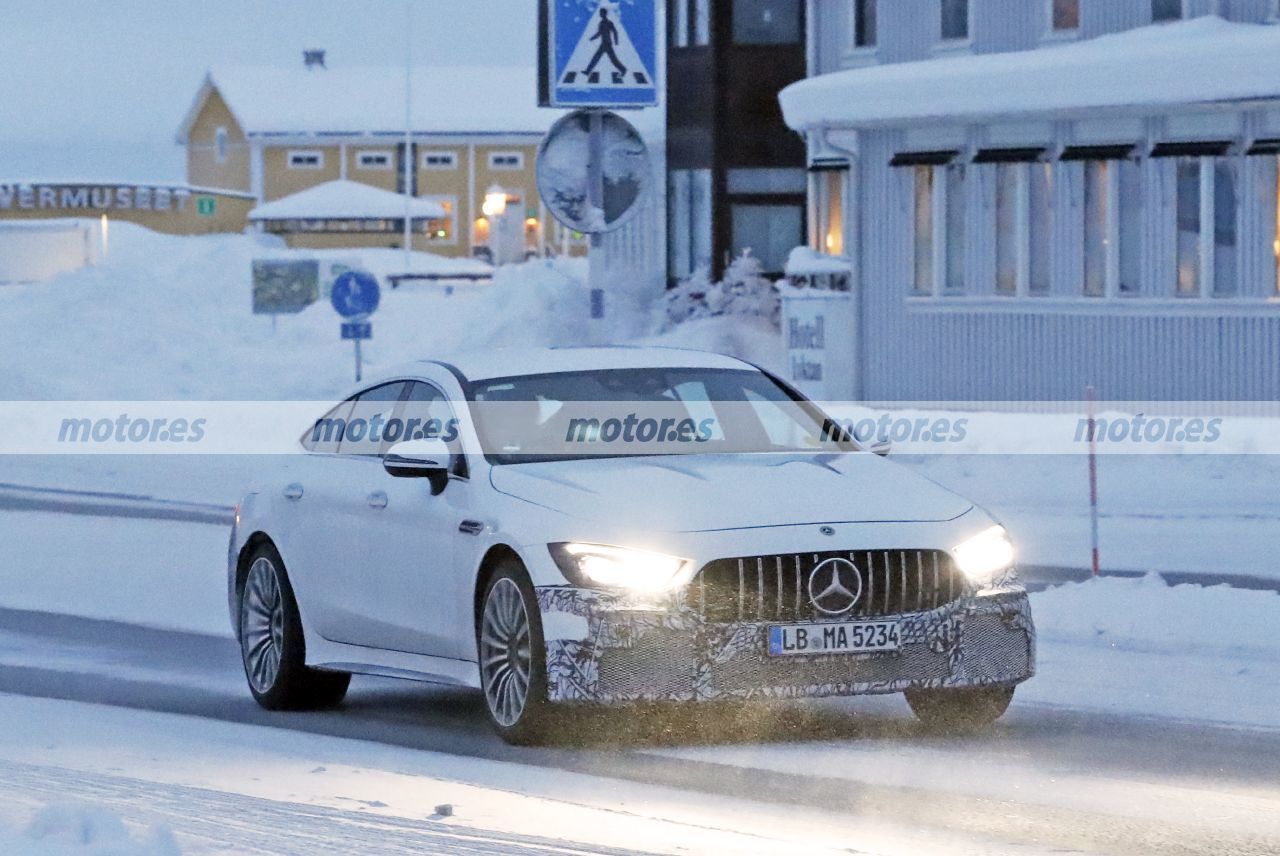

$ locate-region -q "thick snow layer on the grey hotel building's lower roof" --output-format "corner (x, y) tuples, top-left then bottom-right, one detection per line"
(780, 15), (1280, 131)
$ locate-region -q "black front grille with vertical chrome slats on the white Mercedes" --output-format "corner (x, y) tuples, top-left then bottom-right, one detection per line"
(686, 550), (965, 623)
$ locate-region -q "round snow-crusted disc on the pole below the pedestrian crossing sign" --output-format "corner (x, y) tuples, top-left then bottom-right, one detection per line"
(538, 110), (652, 234)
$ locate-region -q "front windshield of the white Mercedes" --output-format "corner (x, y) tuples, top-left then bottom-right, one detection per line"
(470, 369), (855, 464)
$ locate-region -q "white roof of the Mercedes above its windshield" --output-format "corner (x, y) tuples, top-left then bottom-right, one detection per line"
(378, 345), (754, 381)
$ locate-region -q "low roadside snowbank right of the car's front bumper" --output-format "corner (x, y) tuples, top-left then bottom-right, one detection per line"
(1033, 573), (1280, 660)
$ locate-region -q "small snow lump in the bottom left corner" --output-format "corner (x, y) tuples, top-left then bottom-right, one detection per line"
(0, 804), (180, 856)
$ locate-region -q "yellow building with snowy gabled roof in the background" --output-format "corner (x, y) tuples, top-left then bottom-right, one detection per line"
(178, 55), (567, 261)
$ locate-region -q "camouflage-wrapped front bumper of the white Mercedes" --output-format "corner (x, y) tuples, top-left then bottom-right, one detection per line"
(536, 586), (1036, 704)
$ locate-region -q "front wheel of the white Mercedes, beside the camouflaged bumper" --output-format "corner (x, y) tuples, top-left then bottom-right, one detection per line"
(476, 559), (552, 746)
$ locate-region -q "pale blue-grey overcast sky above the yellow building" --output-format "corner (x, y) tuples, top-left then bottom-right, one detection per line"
(0, 0), (536, 182)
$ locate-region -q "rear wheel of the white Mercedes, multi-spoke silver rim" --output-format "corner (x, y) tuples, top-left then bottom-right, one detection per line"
(239, 544), (351, 710)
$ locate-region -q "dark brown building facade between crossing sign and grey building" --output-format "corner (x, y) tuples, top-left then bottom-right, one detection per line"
(667, 0), (803, 281)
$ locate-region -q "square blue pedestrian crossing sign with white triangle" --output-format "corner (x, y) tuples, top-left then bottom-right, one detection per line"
(539, 0), (658, 109)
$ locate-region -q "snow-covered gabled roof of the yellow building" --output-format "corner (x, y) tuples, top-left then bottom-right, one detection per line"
(178, 65), (561, 143)
